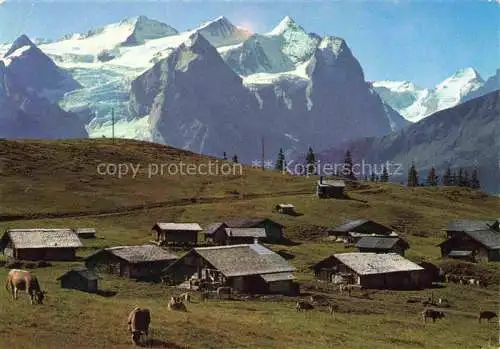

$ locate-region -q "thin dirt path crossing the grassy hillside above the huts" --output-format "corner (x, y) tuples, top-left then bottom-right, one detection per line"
(0, 190), (313, 222)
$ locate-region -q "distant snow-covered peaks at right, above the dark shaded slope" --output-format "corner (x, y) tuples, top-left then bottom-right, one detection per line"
(372, 68), (494, 122)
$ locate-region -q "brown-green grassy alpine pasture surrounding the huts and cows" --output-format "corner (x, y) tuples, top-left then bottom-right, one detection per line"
(0, 141), (500, 349)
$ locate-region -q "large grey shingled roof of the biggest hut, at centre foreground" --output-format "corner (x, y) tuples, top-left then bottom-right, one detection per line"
(166, 244), (295, 277)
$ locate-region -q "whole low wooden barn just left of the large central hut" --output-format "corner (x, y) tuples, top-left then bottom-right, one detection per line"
(85, 245), (178, 280)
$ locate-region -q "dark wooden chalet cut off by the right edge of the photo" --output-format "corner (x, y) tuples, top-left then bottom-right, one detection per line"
(438, 220), (500, 262)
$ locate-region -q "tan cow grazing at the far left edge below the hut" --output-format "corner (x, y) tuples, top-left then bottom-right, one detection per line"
(5, 269), (47, 304)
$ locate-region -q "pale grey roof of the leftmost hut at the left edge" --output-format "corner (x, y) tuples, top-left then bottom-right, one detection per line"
(0, 229), (83, 249)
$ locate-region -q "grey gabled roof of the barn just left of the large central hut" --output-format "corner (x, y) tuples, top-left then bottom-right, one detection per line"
(86, 245), (178, 263)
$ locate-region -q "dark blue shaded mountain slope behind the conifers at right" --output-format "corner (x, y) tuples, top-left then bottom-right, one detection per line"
(319, 91), (500, 193)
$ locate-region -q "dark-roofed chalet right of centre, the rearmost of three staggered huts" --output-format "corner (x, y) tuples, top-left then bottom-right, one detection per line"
(327, 219), (398, 243)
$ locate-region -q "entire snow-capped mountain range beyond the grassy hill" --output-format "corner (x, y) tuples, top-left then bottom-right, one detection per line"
(0, 16), (500, 186)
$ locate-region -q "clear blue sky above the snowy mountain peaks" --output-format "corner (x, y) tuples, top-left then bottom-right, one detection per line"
(0, 0), (500, 87)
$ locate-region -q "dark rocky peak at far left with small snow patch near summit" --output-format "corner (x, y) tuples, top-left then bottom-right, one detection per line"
(0, 35), (87, 139)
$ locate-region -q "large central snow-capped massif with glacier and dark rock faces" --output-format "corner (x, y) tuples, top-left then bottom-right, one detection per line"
(0, 16), (408, 161)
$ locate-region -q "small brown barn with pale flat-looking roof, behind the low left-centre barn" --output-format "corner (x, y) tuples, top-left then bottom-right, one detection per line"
(152, 223), (203, 245)
